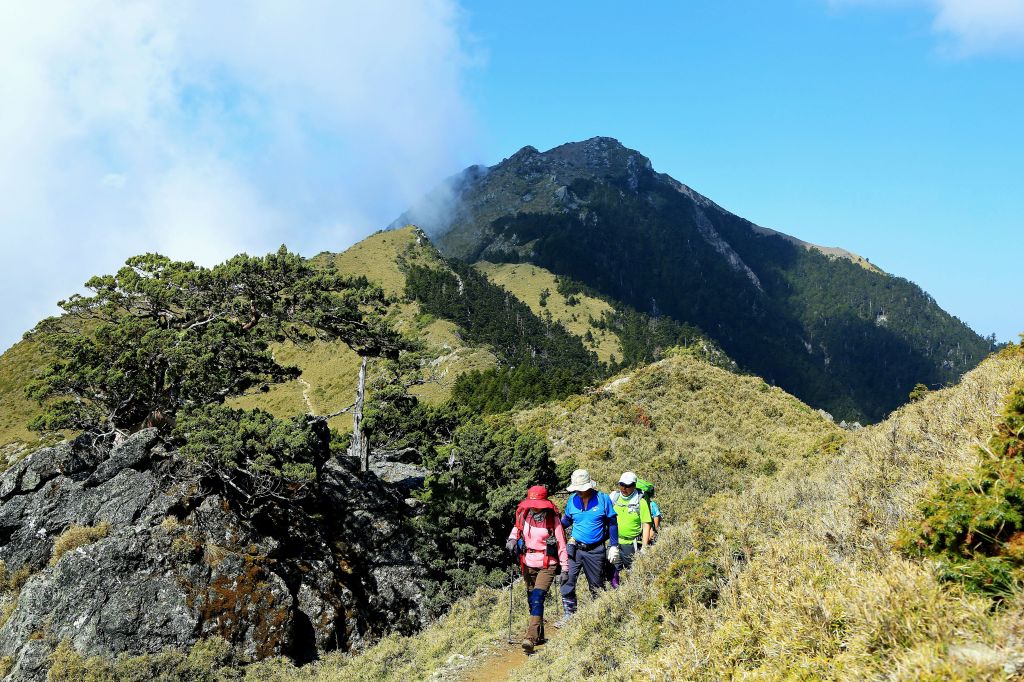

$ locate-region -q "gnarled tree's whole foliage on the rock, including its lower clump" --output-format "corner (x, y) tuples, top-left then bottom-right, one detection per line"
(29, 247), (408, 501)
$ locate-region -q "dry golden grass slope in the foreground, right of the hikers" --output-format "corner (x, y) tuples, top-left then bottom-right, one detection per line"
(517, 352), (1024, 680)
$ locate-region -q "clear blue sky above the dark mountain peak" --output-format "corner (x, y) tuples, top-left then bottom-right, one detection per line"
(466, 0), (1024, 340)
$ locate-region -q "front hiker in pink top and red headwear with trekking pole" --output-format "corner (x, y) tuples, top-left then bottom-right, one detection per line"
(505, 485), (569, 653)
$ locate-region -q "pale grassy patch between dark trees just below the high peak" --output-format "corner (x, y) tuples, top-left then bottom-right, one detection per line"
(474, 261), (623, 363)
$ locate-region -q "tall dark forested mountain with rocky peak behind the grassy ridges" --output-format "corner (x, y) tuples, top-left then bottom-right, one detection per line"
(396, 137), (990, 422)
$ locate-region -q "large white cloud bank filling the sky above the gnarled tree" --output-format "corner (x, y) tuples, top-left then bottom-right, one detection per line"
(0, 0), (473, 348)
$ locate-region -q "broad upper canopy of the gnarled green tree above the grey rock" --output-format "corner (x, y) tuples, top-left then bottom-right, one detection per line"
(29, 247), (404, 434)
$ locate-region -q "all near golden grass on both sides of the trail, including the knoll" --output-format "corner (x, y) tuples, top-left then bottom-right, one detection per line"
(245, 349), (1024, 680)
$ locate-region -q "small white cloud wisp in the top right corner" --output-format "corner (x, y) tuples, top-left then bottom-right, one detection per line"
(830, 0), (1024, 56)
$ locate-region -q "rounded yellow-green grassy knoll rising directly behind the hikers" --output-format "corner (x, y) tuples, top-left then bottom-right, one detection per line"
(516, 353), (845, 512)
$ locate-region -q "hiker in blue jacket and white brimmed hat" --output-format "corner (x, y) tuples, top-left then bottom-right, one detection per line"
(555, 469), (618, 628)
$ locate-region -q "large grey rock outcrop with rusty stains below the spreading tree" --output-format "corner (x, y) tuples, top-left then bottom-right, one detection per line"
(0, 429), (425, 680)
